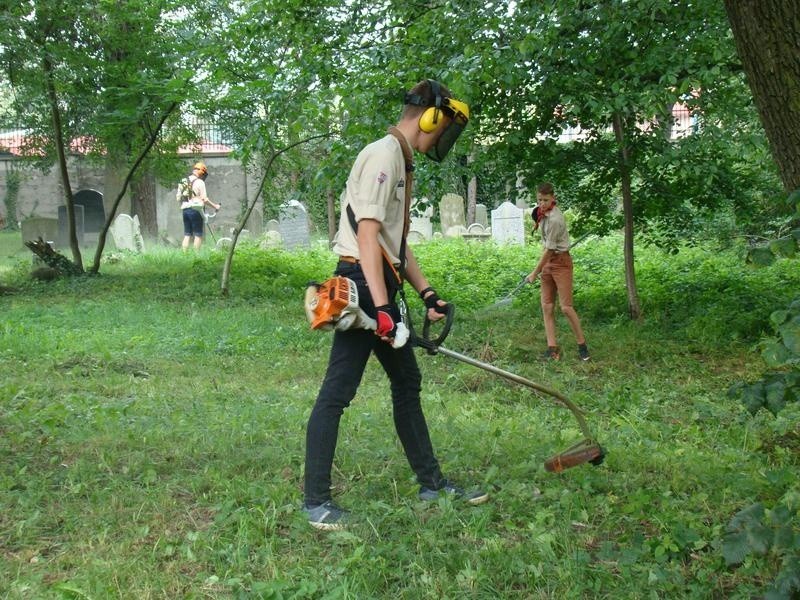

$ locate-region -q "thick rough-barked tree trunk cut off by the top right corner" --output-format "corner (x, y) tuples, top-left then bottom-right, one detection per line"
(725, 0), (800, 193)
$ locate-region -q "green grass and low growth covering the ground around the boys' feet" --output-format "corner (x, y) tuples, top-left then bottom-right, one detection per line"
(0, 234), (800, 599)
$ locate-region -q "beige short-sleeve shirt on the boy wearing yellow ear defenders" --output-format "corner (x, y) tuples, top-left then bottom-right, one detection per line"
(333, 135), (406, 264)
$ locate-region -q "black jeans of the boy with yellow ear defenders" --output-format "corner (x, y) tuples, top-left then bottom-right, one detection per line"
(305, 263), (443, 506)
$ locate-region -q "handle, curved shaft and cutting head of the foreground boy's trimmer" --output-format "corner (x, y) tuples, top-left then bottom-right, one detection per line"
(409, 304), (605, 473)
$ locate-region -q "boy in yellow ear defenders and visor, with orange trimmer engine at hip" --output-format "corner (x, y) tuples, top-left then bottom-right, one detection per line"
(303, 79), (488, 531)
